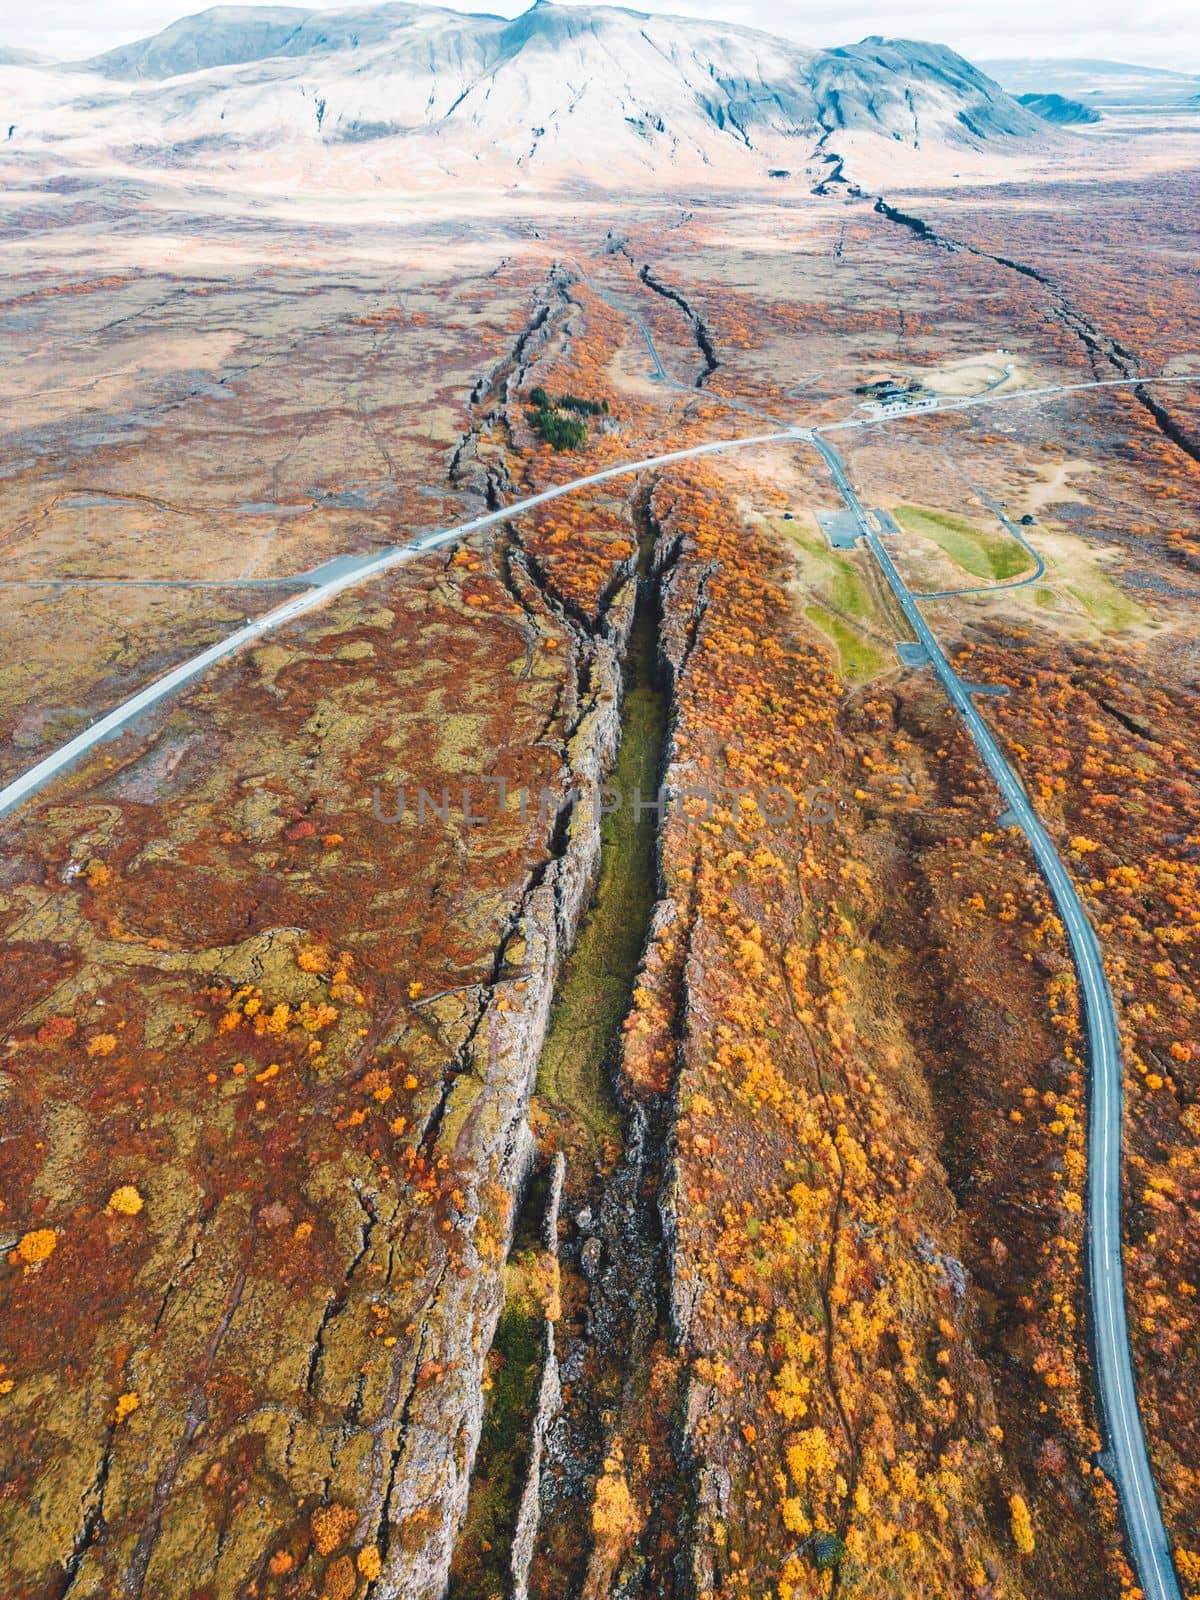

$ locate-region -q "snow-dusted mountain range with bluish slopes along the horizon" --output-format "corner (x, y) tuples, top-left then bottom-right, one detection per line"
(0, 0), (1046, 182)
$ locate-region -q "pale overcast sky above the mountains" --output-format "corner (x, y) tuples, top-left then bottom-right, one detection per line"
(0, 0), (1200, 72)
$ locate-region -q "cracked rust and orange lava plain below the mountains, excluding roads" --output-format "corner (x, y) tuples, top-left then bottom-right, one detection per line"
(0, 46), (1200, 1600)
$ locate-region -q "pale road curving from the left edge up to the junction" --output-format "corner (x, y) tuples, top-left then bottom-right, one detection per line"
(0, 429), (800, 816)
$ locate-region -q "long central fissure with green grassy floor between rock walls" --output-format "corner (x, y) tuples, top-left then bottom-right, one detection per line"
(450, 494), (691, 1600)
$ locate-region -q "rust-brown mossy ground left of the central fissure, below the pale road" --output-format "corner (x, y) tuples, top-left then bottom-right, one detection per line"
(0, 243), (649, 1600)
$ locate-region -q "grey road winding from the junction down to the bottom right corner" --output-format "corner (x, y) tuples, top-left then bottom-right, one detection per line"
(811, 432), (1181, 1600)
